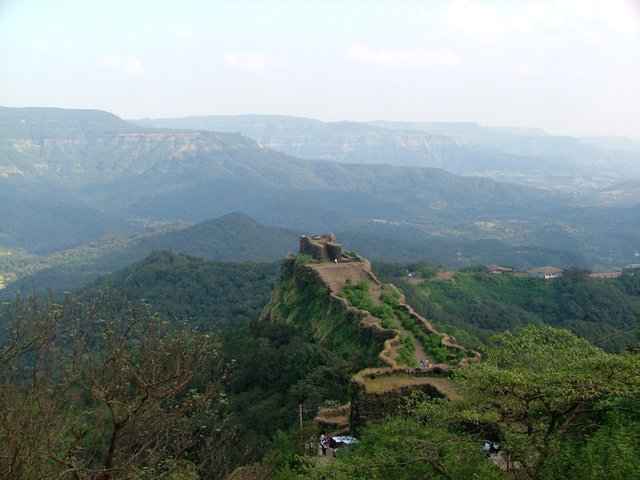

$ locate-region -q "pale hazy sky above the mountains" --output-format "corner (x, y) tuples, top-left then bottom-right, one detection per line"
(0, 0), (640, 140)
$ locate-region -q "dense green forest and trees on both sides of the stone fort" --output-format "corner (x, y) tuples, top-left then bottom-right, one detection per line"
(0, 252), (640, 480)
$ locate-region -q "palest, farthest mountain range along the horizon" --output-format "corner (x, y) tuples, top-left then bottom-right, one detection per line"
(135, 115), (640, 192)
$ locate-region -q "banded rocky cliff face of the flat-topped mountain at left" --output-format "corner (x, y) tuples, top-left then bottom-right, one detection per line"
(0, 132), (256, 185)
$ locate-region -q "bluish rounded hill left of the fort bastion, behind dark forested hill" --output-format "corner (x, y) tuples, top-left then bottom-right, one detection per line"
(0, 213), (298, 297)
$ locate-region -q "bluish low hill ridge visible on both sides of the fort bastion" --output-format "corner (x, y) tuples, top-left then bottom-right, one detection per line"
(0, 212), (588, 297)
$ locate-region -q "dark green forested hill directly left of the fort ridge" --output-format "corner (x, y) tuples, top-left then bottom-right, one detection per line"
(82, 252), (280, 332)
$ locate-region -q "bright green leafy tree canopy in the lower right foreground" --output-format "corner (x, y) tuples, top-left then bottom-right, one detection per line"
(284, 326), (640, 480)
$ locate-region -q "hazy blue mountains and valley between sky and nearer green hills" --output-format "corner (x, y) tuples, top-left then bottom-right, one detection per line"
(0, 108), (640, 296)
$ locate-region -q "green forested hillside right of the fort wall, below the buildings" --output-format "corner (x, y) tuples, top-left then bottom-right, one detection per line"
(377, 263), (640, 352)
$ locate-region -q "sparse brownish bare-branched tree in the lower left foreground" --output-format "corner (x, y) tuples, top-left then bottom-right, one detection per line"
(0, 292), (234, 480)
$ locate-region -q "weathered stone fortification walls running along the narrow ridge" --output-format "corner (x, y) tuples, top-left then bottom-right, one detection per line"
(276, 240), (480, 433)
